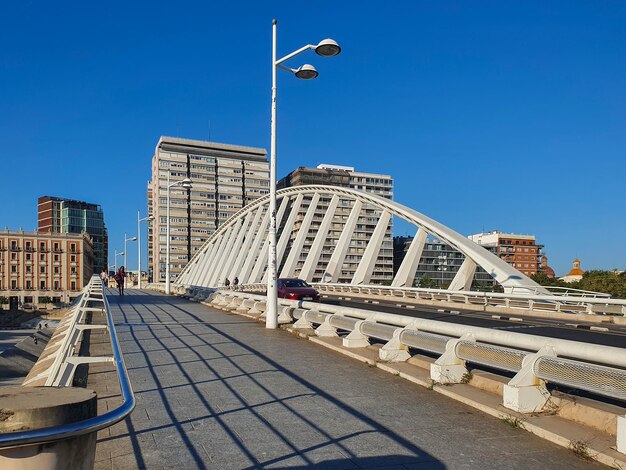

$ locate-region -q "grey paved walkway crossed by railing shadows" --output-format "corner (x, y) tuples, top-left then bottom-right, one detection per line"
(88, 290), (600, 470)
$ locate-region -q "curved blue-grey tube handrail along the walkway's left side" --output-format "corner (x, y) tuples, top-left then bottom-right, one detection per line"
(0, 276), (135, 448)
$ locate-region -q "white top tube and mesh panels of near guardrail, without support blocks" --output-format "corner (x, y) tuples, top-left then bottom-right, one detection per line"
(196, 290), (626, 401)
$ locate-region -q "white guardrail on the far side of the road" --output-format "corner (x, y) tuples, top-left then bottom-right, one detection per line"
(230, 283), (626, 316)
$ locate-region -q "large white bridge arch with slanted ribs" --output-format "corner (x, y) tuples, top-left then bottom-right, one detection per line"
(176, 185), (547, 294)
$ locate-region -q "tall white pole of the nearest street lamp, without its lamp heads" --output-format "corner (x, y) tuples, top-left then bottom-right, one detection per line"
(265, 20), (278, 328)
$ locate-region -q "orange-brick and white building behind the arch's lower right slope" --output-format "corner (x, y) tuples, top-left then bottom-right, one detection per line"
(467, 230), (543, 276)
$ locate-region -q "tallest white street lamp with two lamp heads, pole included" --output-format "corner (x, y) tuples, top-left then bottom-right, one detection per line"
(265, 20), (341, 328)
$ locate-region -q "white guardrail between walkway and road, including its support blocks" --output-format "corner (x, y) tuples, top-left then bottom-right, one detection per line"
(162, 285), (626, 453)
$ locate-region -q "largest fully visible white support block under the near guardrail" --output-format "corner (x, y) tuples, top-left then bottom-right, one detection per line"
(502, 346), (556, 413)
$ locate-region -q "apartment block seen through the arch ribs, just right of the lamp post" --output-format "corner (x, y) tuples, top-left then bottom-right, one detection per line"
(277, 164), (393, 284)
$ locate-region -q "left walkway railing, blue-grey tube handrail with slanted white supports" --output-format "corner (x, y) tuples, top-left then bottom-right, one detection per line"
(0, 276), (135, 448)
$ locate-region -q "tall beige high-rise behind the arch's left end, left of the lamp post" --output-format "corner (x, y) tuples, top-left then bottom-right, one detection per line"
(148, 137), (269, 282)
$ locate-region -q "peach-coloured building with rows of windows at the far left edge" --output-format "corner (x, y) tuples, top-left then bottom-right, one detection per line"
(0, 230), (94, 308)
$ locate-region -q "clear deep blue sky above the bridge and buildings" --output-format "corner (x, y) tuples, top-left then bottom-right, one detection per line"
(0, 1), (626, 275)
